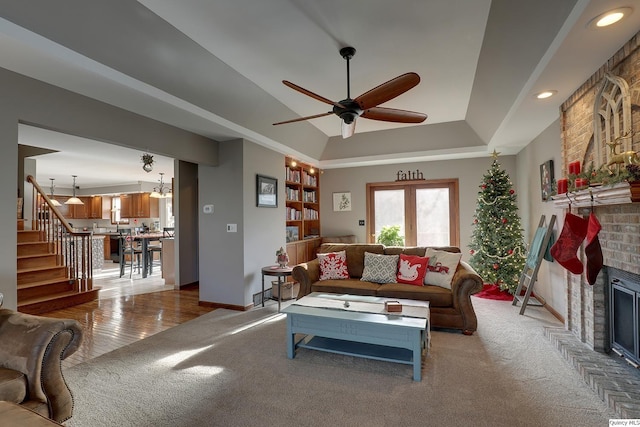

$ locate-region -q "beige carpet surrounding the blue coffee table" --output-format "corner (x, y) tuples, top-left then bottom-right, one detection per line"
(65, 298), (616, 427)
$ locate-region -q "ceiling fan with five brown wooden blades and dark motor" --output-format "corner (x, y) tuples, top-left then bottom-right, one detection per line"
(274, 47), (427, 138)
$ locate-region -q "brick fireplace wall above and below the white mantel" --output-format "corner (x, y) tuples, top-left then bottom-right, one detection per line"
(556, 33), (640, 358)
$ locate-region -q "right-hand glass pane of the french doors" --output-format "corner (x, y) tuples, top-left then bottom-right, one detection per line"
(416, 188), (451, 246)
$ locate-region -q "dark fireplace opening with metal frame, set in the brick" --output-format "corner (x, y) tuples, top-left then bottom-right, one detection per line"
(607, 267), (640, 368)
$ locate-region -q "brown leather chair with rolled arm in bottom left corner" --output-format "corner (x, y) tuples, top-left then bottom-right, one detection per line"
(0, 309), (82, 425)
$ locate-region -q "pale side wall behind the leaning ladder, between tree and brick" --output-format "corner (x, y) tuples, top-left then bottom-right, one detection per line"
(516, 120), (567, 316)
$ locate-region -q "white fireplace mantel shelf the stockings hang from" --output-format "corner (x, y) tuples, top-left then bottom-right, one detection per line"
(551, 181), (640, 209)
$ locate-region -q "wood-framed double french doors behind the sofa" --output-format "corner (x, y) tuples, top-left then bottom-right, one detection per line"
(367, 179), (460, 246)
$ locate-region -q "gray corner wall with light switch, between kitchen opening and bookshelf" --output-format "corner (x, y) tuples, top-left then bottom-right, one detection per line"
(199, 141), (285, 307)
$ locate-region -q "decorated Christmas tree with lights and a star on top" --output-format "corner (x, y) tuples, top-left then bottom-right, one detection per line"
(469, 151), (526, 294)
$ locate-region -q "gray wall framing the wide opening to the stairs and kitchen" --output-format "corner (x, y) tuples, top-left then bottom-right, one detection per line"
(0, 68), (218, 309)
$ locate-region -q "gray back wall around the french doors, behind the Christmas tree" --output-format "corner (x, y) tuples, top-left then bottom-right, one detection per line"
(320, 156), (516, 259)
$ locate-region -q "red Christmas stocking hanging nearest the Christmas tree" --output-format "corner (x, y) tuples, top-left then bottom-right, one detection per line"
(551, 212), (588, 274)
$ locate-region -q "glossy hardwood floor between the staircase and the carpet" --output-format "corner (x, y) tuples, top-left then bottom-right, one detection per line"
(42, 264), (218, 368)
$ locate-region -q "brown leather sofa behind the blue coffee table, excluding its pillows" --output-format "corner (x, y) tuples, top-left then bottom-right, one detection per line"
(292, 243), (483, 335)
